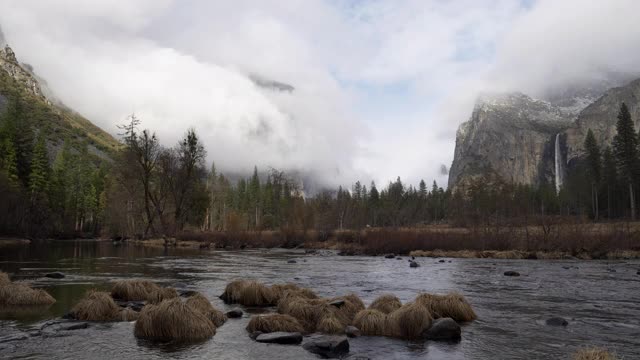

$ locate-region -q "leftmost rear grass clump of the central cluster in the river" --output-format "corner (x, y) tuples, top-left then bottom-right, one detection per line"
(220, 280), (277, 306)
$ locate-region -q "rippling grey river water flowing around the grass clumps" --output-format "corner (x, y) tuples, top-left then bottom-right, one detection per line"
(0, 241), (640, 359)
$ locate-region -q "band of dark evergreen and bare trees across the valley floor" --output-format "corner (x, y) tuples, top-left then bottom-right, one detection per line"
(0, 91), (640, 255)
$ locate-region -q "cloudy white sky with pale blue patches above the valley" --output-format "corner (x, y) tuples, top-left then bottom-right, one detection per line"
(0, 0), (640, 190)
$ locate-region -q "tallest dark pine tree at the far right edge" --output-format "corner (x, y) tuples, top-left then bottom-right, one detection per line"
(613, 103), (638, 220)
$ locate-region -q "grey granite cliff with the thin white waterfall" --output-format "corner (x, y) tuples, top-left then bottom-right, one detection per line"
(449, 79), (640, 190)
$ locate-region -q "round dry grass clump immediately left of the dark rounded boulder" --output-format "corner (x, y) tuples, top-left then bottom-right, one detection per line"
(386, 302), (432, 339)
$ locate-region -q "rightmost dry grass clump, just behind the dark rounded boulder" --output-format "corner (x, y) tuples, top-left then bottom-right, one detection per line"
(415, 293), (477, 322)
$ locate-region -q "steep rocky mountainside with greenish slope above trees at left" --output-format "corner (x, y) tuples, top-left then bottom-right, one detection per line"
(0, 39), (120, 158)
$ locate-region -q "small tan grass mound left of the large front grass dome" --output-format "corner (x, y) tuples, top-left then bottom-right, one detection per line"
(71, 290), (122, 321)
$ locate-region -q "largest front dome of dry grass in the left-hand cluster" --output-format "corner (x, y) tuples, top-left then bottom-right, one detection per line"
(134, 298), (216, 342)
